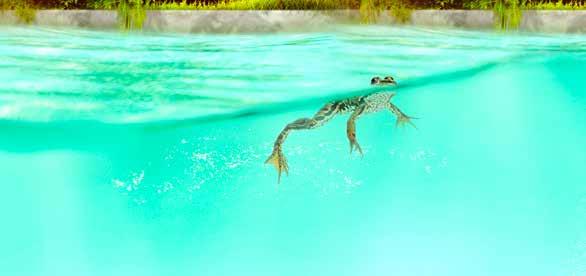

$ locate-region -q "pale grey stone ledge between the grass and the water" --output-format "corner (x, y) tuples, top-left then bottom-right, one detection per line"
(0, 10), (586, 33)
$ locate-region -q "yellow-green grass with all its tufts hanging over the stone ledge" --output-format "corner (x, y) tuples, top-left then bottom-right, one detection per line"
(0, 0), (586, 30)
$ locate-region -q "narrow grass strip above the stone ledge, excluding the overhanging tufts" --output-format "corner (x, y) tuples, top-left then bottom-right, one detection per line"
(0, 0), (586, 10)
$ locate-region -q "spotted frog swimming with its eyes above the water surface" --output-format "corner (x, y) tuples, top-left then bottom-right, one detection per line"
(265, 77), (415, 183)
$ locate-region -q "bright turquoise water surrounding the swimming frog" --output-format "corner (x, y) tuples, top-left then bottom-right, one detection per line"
(0, 26), (586, 275)
